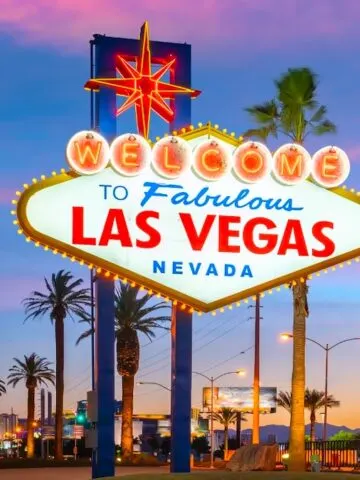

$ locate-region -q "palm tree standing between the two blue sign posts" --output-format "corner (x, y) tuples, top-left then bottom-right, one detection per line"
(77, 283), (170, 459)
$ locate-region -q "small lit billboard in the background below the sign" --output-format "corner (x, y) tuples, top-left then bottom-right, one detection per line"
(203, 387), (277, 413)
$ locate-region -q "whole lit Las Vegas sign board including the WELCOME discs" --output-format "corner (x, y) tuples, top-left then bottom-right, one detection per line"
(15, 125), (360, 312)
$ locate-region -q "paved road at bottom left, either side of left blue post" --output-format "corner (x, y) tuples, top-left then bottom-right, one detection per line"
(0, 467), (169, 480)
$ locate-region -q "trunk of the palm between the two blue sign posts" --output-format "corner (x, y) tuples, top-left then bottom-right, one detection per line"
(121, 376), (135, 460)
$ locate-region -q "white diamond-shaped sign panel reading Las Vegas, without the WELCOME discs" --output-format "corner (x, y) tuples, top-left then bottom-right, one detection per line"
(18, 125), (360, 311)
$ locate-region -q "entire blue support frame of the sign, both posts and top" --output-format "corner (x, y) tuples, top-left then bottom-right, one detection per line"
(93, 31), (192, 478)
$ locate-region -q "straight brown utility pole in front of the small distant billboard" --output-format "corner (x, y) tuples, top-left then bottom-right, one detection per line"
(252, 294), (262, 445)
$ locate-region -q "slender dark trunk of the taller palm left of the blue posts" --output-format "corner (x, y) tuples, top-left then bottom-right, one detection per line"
(55, 317), (64, 460)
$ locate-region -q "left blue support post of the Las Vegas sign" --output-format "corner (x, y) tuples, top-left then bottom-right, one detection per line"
(92, 38), (116, 478)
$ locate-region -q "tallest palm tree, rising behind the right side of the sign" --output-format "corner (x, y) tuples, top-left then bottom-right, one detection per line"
(244, 68), (336, 471)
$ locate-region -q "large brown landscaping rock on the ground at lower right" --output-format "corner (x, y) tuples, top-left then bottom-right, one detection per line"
(226, 444), (277, 472)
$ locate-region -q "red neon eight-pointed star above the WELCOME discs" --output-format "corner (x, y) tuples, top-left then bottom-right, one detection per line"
(85, 22), (201, 138)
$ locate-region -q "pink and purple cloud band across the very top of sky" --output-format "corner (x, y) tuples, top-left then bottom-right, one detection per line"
(0, 0), (360, 53)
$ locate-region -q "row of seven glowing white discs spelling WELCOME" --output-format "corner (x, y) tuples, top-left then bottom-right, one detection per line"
(66, 131), (350, 188)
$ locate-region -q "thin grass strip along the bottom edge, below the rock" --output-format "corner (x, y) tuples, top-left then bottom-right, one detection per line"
(108, 472), (356, 480)
